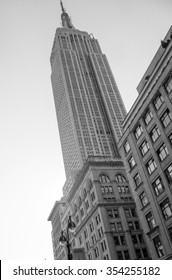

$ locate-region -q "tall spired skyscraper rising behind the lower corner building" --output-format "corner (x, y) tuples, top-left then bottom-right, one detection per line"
(51, 1), (126, 178)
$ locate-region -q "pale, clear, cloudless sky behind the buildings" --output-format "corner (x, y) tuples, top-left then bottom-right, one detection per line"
(0, 0), (172, 260)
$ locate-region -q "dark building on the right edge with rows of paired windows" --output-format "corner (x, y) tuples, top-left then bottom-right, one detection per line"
(119, 27), (172, 259)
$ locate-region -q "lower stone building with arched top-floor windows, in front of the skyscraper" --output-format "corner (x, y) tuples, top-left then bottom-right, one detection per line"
(48, 156), (150, 260)
